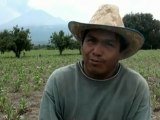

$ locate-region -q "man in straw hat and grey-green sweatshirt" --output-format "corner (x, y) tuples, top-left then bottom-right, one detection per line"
(39, 5), (151, 120)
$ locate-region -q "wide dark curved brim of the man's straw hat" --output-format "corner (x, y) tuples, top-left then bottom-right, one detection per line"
(68, 21), (144, 59)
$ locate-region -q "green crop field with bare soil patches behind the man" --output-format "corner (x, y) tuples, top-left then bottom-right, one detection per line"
(0, 50), (160, 120)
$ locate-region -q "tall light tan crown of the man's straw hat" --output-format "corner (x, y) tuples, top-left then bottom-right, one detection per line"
(89, 4), (124, 27)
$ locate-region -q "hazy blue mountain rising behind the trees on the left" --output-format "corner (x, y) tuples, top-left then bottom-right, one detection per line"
(0, 10), (69, 44)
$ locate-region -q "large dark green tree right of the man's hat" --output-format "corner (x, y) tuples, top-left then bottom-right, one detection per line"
(123, 13), (160, 49)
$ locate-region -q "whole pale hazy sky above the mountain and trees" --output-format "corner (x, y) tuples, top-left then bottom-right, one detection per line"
(0, 0), (160, 24)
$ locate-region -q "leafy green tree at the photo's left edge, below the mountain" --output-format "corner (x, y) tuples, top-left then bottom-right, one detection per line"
(0, 26), (32, 58)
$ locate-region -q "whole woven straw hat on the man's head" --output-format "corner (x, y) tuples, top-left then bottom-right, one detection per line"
(68, 4), (144, 59)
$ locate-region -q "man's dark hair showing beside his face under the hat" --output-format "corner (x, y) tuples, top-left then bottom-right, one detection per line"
(82, 29), (127, 52)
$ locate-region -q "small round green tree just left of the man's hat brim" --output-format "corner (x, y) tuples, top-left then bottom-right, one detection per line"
(49, 30), (72, 55)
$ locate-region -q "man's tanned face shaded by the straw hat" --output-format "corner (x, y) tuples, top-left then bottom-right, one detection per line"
(81, 30), (120, 79)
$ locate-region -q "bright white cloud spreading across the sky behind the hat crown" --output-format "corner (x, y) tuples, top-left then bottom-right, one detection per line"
(28, 0), (160, 22)
